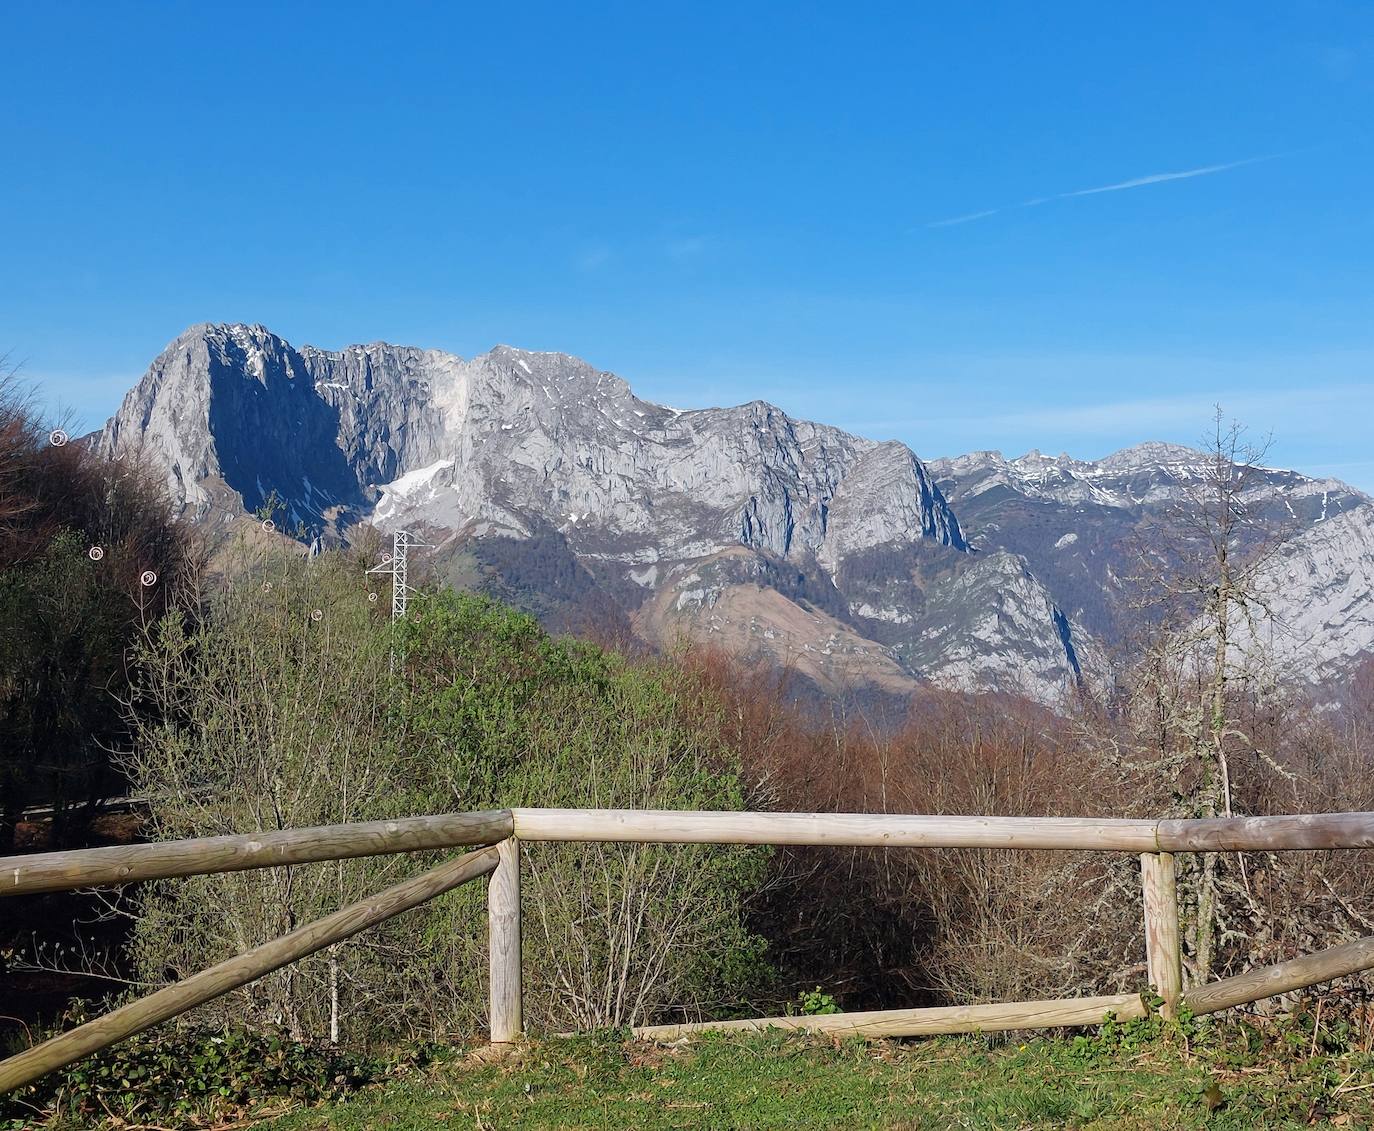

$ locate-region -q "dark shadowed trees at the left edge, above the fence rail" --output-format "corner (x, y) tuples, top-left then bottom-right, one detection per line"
(0, 367), (201, 852)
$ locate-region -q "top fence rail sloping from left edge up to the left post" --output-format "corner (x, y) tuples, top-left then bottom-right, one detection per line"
(0, 809), (514, 896)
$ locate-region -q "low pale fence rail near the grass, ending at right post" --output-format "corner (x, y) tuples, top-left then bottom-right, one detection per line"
(635, 994), (1149, 1040)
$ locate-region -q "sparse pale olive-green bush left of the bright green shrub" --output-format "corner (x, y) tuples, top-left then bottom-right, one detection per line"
(126, 551), (403, 1039)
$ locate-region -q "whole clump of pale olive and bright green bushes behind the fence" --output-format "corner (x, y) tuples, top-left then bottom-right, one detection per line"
(129, 555), (763, 1039)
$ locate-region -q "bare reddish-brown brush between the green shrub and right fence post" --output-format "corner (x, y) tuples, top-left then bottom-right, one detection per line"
(714, 681), (1146, 1009)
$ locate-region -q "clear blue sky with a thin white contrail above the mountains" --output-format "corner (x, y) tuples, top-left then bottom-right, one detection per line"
(0, 0), (1374, 489)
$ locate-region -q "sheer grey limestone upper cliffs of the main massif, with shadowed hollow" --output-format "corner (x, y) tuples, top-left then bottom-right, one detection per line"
(99, 326), (963, 573)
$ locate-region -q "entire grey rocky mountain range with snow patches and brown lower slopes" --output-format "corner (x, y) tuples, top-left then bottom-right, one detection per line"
(93, 324), (1374, 702)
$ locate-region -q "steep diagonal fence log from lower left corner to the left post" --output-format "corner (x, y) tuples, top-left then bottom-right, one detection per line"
(0, 847), (499, 1093)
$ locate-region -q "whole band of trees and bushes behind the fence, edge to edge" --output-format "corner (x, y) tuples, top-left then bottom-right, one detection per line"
(0, 376), (1374, 1117)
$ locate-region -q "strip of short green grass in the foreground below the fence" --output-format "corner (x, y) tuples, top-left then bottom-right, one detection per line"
(259, 1029), (1374, 1131)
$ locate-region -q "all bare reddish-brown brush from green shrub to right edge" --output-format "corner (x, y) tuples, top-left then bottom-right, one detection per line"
(684, 640), (1374, 1007)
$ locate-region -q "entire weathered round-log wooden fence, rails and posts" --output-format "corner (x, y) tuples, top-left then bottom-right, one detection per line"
(0, 809), (1374, 1093)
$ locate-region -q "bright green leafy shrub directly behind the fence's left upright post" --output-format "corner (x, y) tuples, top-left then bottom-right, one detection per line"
(404, 592), (765, 1029)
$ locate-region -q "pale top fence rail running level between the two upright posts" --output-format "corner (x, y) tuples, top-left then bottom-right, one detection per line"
(511, 809), (1156, 852)
